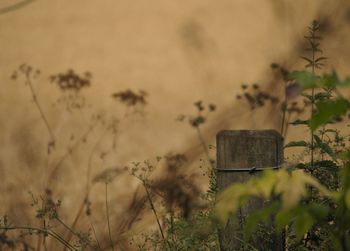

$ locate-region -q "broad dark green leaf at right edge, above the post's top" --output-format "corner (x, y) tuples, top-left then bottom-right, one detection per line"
(310, 98), (350, 131)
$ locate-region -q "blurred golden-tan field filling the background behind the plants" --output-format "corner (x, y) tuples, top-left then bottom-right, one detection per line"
(0, 0), (350, 250)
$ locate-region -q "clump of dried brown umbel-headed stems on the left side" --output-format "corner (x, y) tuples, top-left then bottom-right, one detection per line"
(0, 64), (153, 250)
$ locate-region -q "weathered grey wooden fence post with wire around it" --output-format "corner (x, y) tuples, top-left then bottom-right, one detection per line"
(216, 130), (284, 251)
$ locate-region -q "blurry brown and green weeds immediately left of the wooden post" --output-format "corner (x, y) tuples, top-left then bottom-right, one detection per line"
(129, 154), (216, 250)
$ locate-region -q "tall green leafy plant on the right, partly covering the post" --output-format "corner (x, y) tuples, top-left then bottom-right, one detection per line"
(215, 22), (350, 250)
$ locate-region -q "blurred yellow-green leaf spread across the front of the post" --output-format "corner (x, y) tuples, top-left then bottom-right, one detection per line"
(215, 169), (333, 224)
